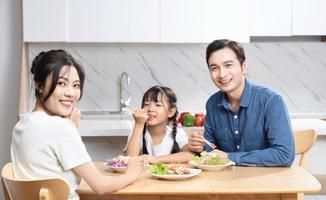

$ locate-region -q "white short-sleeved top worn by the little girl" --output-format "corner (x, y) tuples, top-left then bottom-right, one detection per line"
(124, 126), (188, 156)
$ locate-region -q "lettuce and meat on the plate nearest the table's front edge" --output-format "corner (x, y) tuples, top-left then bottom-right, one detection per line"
(150, 163), (191, 175)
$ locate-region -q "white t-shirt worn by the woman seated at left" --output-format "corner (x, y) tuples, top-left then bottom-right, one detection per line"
(11, 112), (91, 200)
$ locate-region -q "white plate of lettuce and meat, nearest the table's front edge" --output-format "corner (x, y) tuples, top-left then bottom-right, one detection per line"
(150, 163), (201, 180)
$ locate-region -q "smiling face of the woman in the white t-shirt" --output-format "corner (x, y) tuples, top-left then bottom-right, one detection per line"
(39, 66), (80, 117)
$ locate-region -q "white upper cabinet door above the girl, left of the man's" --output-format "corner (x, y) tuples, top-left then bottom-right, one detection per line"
(160, 0), (203, 42)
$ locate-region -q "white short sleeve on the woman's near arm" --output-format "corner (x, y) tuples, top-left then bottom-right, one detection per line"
(53, 120), (91, 170)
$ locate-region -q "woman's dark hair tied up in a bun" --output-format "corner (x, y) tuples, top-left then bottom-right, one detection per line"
(31, 49), (85, 104)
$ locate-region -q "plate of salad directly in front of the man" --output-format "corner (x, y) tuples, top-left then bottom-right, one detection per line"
(189, 151), (234, 171)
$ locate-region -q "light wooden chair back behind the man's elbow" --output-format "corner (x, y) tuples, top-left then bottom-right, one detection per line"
(293, 129), (317, 168)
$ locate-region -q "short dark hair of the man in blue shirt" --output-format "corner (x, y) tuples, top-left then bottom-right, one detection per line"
(206, 39), (246, 67)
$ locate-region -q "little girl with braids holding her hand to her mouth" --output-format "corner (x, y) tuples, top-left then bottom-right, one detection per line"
(124, 86), (193, 163)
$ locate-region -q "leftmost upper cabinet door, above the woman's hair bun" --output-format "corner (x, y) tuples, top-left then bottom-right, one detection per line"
(22, 0), (66, 42)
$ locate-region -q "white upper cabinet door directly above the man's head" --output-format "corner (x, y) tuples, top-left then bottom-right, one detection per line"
(203, 0), (250, 42)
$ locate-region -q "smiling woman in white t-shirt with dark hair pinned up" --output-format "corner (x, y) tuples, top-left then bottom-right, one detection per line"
(11, 50), (142, 199)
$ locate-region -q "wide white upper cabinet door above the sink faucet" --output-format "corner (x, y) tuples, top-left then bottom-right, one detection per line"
(68, 0), (160, 42)
